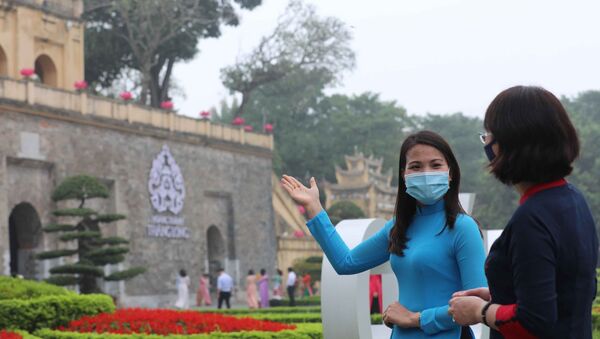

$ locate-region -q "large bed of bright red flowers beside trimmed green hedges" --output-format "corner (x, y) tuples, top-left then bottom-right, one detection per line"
(59, 308), (296, 335)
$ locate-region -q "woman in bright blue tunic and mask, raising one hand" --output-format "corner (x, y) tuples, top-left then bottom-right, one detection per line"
(281, 131), (487, 339)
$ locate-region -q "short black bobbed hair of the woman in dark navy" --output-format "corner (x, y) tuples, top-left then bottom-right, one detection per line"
(483, 86), (579, 185)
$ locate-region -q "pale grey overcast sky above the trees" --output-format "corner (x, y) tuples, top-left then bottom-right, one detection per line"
(174, 0), (600, 117)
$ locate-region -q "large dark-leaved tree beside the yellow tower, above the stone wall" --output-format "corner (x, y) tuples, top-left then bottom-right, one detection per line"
(82, 0), (262, 107)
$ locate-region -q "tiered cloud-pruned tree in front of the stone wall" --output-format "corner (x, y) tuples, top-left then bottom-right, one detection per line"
(37, 175), (145, 293)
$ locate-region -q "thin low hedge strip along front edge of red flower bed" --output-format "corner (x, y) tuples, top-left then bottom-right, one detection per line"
(35, 324), (323, 339)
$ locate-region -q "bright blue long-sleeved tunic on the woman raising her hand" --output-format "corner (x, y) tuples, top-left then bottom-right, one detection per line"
(307, 200), (487, 339)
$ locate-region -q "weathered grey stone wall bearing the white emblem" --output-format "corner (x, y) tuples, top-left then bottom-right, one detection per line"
(0, 104), (277, 306)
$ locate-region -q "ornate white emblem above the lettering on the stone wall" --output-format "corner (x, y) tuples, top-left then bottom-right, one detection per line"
(148, 145), (185, 214)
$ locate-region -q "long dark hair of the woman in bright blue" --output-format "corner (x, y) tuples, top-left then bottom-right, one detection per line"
(389, 131), (465, 256)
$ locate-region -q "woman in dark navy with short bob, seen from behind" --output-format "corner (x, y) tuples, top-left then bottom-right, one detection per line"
(449, 86), (598, 339)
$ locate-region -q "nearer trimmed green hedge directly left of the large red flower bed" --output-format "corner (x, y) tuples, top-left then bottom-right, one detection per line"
(0, 294), (115, 332)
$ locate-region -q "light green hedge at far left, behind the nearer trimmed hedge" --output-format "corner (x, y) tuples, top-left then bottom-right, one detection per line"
(0, 276), (75, 300)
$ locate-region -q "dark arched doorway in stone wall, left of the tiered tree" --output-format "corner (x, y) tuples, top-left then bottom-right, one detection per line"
(8, 202), (42, 278)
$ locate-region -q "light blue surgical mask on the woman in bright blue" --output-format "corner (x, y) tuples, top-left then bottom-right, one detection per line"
(404, 172), (450, 205)
